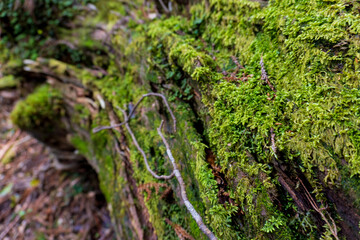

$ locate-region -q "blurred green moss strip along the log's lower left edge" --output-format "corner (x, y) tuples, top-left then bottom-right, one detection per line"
(71, 112), (133, 236)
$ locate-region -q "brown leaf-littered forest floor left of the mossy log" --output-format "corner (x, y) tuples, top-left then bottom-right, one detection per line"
(0, 89), (114, 240)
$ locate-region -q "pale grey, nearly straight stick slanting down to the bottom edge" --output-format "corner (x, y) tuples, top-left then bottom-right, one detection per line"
(157, 121), (217, 240)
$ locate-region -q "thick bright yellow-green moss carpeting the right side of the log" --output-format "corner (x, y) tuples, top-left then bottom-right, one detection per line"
(123, 1), (359, 238)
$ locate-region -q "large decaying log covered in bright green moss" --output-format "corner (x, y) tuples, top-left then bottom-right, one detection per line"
(4, 0), (360, 239)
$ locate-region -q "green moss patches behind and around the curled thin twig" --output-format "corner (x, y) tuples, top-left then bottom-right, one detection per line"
(119, 99), (208, 239)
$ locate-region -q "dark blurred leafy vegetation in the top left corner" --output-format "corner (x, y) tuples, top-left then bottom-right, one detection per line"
(0, 0), (94, 60)
